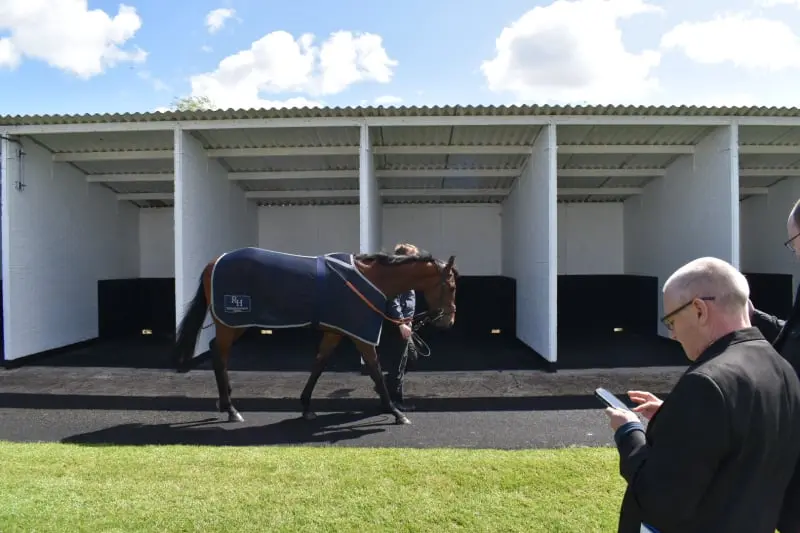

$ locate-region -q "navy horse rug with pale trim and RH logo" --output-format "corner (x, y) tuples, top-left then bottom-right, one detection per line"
(211, 247), (386, 346)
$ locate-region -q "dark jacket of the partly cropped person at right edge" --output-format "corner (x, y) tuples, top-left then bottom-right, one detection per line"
(750, 287), (800, 533)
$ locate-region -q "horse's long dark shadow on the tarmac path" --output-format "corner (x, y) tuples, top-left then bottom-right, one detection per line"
(61, 412), (394, 446)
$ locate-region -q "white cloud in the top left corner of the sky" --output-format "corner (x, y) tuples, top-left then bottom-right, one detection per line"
(0, 0), (147, 79)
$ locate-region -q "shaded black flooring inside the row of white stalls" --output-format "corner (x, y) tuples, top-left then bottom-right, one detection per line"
(10, 333), (688, 372)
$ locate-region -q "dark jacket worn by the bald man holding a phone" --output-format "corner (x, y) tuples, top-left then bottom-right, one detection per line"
(614, 327), (800, 533)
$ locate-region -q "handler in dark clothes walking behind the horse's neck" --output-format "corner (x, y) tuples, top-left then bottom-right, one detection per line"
(378, 243), (419, 411)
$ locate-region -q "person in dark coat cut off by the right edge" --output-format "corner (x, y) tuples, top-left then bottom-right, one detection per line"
(748, 200), (800, 533)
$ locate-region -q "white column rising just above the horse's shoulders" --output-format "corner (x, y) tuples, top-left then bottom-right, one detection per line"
(358, 125), (383, 253)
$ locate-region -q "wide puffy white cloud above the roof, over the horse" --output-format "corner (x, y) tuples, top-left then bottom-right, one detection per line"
(190, 31), (397, 108)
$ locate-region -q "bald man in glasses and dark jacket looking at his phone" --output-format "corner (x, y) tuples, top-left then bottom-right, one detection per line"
(606, 257), (800, 533)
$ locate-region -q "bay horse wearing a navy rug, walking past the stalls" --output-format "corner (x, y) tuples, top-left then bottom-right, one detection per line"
(173, 247), (458, 424)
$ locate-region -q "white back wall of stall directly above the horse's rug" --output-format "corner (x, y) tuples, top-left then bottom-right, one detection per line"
(258, 205), (359, 255)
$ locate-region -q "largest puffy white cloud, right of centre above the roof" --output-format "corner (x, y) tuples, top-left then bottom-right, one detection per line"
(481, 0), (662, 104)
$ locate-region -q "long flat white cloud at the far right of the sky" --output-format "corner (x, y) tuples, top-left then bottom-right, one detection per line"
(661, 13), (800, 71)
